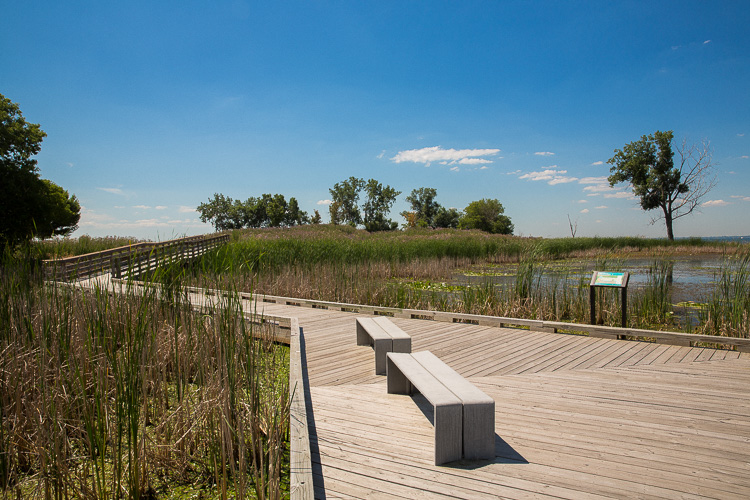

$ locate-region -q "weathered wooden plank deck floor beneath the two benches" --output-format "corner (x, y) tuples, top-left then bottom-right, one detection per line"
(258, 303), (750, 499)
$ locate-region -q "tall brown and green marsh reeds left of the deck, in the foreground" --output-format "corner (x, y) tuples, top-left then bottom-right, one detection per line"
(0, 258), (289, 499)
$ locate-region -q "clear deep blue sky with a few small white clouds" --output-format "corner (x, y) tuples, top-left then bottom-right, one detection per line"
(0, 0), (750, 239)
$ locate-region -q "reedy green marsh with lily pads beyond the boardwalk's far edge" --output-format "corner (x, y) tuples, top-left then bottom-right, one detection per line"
(178, 225), (748, 336)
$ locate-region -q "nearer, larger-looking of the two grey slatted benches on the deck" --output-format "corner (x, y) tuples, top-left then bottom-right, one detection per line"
(387, 351), (495, 465)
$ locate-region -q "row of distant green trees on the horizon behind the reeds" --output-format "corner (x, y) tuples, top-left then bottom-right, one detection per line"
(197, 176), (514, 234)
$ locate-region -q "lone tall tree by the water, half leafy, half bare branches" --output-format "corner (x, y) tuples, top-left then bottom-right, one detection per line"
(607, 130), (716, 240)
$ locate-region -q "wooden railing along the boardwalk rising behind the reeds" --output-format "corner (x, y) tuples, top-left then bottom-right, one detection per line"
(44, 233), (229, 281)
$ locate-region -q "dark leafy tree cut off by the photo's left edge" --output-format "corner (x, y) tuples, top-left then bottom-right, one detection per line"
(0, 94), (81, 248)
